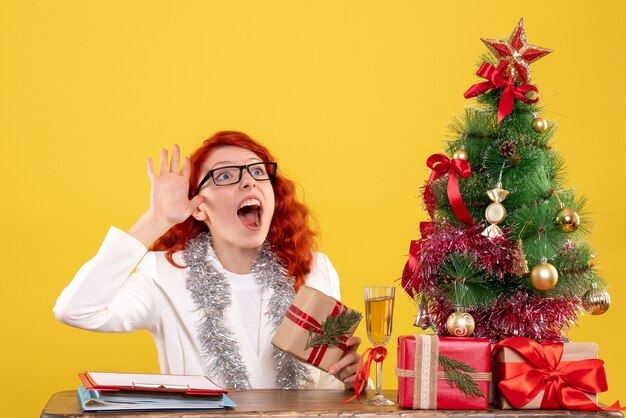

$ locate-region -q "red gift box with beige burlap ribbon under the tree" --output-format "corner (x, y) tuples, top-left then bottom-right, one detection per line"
(396, 335), (491, 410)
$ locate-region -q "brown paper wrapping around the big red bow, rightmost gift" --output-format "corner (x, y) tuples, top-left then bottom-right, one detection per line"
(493, 343), (598, 409)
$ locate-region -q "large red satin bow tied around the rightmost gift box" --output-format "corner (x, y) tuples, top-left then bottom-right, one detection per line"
(494, 337), (625, 411)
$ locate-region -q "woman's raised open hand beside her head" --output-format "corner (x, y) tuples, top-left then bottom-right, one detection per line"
(128, 144), (203, 247)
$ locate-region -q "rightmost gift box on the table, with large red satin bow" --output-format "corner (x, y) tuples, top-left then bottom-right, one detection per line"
(493, 337), (621, 411)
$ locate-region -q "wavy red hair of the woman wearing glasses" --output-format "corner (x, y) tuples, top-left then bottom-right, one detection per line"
(151, 131), (315, 290)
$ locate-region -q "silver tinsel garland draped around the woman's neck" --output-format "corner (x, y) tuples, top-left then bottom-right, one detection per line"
(183, 233), (311, 389)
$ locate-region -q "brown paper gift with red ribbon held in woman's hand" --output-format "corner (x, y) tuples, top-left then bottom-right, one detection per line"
(272, 286), (359, 371)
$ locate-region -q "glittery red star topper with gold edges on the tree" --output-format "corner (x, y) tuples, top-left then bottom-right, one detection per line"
(481, 18), (552, 84)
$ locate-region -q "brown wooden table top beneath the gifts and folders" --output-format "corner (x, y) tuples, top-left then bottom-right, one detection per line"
(41, 389), (623, 418)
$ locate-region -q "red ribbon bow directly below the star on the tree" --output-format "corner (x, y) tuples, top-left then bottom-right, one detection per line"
(463, 61), (539, 123)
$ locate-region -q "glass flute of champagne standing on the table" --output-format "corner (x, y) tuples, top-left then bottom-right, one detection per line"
(363, 286), (396, 405)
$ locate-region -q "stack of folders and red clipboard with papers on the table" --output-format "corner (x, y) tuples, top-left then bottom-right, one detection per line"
(78, 372), (235, 411)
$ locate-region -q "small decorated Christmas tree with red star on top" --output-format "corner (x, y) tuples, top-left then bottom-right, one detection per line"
(402, 20), (610, 342)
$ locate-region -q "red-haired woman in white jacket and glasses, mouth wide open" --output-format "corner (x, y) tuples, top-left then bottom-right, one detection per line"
(54, 131), (360, 389)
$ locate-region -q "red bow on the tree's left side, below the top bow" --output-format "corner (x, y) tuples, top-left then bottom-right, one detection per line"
(424, 154), (474, 225)
